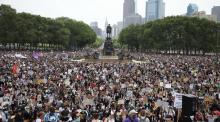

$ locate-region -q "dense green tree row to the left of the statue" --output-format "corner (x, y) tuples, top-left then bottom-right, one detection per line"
(0, 4), (96, 50)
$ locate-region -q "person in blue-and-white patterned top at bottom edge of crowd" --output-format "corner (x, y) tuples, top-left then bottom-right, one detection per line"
(44, 107), (59, 122)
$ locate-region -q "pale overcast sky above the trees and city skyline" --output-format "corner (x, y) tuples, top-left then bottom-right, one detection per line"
(0, 0), (220, 28)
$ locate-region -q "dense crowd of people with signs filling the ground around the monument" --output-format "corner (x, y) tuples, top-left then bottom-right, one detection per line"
(0, 51), (220, 122)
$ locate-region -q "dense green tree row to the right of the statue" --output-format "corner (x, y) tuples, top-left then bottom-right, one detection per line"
(119, 16), (220, 54)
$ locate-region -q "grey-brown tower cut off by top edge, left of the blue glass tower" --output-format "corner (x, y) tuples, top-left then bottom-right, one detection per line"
(123, 0), (135, 22)
